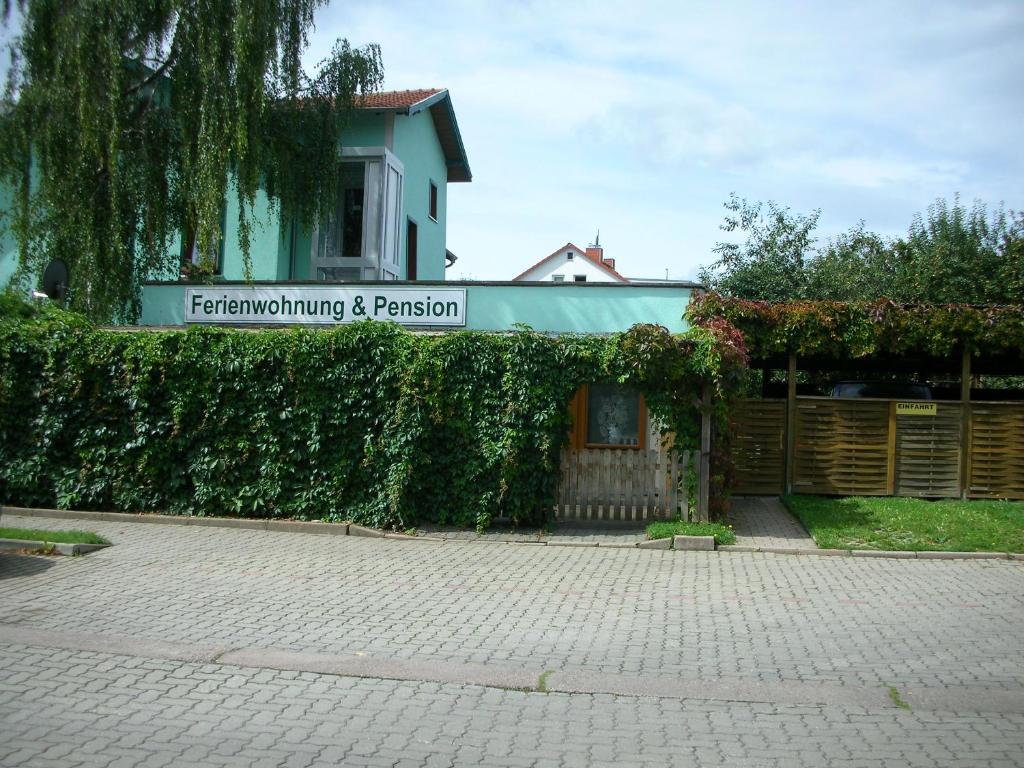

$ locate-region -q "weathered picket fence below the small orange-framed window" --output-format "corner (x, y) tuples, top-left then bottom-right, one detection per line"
(555, 447), (695, 522)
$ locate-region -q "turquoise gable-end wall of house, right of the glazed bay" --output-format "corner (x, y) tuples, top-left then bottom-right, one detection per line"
(392, 111), (447, 280)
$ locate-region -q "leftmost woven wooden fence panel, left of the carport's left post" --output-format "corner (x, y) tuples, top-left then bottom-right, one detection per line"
(732, 399), (785, 496)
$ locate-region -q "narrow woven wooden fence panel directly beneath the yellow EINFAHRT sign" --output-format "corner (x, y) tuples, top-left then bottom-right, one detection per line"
(895, 402), (962, 498)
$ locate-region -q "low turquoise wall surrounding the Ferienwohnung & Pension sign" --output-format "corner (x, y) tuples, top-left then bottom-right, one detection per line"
(140, 281), (692, 334)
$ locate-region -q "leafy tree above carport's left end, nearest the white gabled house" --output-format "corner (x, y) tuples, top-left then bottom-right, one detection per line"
(700, 195), (821, 301)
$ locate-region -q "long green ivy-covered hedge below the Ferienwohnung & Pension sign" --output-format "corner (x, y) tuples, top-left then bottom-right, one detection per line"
(0, 311), (743, 528)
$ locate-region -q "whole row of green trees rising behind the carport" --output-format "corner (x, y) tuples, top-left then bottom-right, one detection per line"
(700, 196), (1024, 304)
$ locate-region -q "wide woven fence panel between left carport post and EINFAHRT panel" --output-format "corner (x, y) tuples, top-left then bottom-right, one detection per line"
(793, 397), (890, 496)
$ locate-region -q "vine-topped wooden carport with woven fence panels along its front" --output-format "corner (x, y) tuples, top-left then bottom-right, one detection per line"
(695, 295), (1024, 499)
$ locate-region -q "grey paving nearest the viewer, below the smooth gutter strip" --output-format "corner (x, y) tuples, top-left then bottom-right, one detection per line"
(8, 646), (1024, 768)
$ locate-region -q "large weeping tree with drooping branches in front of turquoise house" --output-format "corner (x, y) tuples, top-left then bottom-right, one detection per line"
(0, 0), (382, 321)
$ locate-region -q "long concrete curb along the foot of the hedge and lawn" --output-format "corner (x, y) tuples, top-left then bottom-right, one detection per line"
(0, 505), (1024, 562)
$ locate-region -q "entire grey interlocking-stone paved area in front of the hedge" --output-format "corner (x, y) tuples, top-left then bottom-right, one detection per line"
(0, 515), (1024, 766)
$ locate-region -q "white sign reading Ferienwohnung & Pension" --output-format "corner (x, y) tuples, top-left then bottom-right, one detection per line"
(185, 285), (466, 326)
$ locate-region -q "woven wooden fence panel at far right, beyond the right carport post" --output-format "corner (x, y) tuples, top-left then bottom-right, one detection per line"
(968, 402), (1024, 499)
